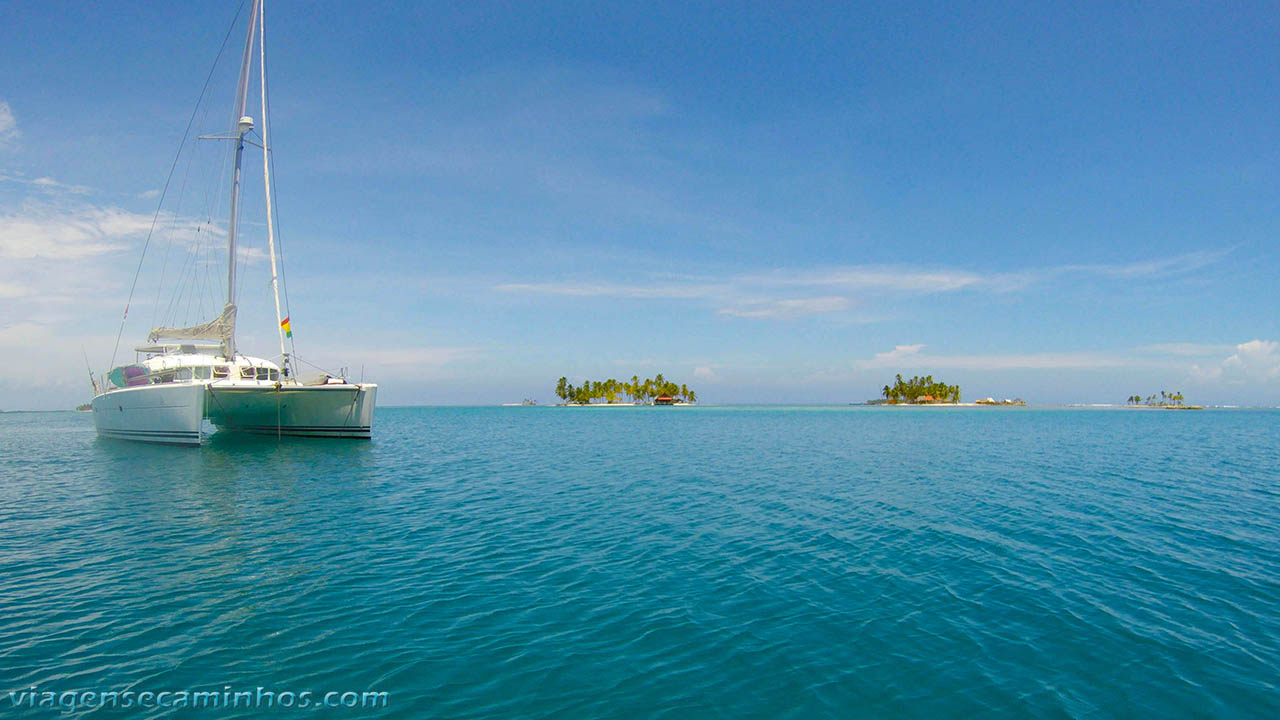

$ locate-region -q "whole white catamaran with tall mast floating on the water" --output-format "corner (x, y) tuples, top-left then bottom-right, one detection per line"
(91, 0), (378, 446)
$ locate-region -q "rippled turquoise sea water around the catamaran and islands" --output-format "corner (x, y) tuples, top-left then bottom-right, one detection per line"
(0, 407), (1280, 719)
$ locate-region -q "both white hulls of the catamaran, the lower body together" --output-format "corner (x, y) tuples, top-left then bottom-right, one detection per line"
(92, 383), (378, 446)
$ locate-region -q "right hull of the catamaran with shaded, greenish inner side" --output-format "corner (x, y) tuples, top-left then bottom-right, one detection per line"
(205, 383), (378, 439)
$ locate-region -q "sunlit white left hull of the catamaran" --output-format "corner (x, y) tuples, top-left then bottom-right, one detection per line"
(92, 384), (205, 445)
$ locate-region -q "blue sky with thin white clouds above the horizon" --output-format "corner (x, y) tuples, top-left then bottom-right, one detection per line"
(0, 0), (1280, 409)
